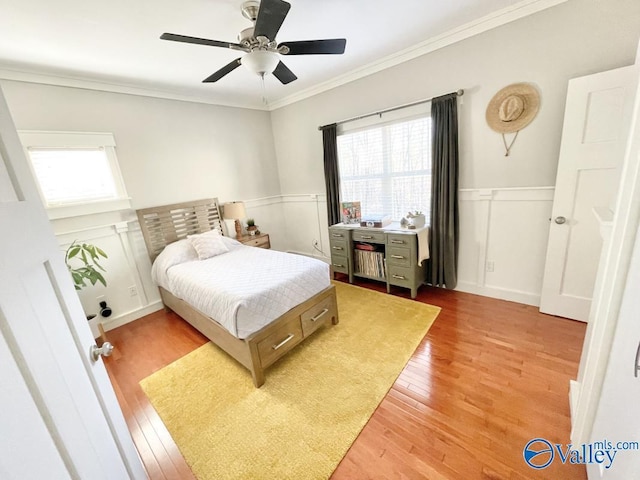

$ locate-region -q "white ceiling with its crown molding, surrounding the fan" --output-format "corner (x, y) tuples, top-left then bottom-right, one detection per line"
(0, 0), (565, 108)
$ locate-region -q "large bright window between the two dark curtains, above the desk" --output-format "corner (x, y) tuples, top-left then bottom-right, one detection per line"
(338, 115), (431, 223)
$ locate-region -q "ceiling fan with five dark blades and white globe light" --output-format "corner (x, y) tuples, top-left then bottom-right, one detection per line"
(160, 0), (347, 85)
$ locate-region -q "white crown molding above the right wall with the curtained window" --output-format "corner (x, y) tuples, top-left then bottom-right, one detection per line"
(269, 0), (568, 111)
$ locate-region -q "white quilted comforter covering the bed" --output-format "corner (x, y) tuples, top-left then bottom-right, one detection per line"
(152, 244), (330, 338)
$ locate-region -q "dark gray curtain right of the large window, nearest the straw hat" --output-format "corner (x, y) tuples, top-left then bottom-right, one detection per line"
(427, 93), (460, 289)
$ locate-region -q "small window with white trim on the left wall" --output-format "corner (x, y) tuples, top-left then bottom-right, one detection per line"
(20, 132), (130, 218)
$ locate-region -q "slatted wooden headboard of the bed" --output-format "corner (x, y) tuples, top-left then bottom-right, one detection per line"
(136, 198), (227, 262)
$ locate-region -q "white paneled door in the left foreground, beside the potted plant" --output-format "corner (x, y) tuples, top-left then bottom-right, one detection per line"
(0, 90), (146, 480)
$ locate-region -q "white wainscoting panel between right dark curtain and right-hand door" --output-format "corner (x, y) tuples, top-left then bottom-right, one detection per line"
(458, 187), (554, 306)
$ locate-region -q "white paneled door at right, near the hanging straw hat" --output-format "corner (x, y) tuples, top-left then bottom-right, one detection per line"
(540, 66), (637, 322)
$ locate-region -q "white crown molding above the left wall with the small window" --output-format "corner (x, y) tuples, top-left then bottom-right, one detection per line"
(0, 67), (268, 111)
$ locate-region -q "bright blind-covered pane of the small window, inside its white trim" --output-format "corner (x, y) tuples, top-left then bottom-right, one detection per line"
(28, 148), (118, 206)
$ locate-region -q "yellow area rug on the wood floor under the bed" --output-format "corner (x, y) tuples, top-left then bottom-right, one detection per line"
(140, 282), (440, 480)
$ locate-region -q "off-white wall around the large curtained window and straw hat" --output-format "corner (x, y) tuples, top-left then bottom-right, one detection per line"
(271, 0), (640, 304)
